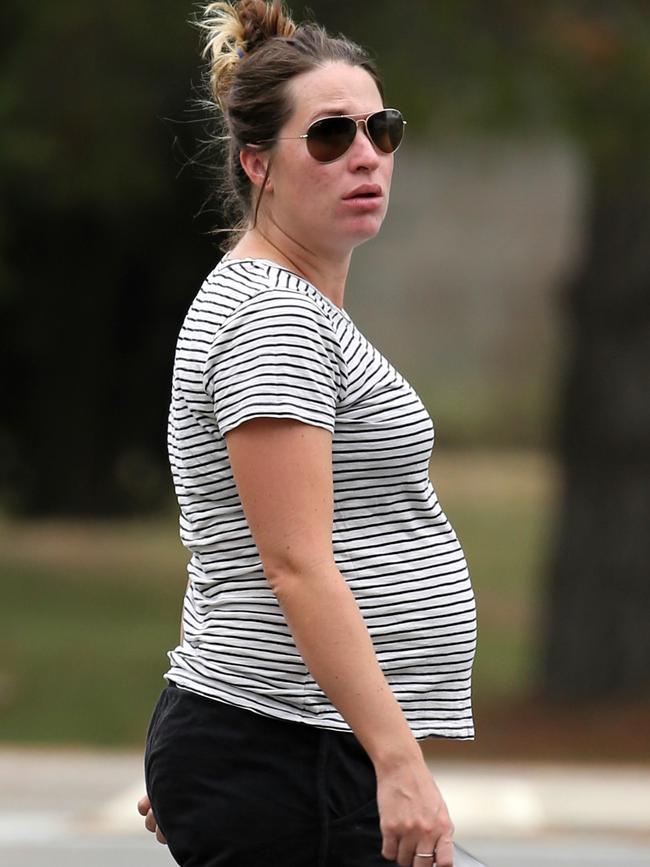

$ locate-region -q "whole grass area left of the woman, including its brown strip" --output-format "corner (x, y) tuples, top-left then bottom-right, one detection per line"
(0, 521), (185, 745)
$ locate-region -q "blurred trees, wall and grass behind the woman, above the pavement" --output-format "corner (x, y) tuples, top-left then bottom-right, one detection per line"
(0, 0), (650, 780)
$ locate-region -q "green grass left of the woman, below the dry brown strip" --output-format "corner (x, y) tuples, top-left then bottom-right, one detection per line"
(0, 563), (183, 744)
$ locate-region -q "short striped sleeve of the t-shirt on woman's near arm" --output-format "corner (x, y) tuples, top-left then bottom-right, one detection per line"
(203, 289), (342, 435)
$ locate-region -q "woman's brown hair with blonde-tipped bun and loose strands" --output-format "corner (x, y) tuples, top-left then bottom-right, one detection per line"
(195, 0), (384, 249)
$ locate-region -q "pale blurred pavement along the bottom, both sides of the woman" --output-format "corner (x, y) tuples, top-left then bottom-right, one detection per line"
(0, 748), (650, 867)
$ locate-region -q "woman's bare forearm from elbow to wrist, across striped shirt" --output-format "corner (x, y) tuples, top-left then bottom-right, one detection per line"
(271, 565), (421, 768)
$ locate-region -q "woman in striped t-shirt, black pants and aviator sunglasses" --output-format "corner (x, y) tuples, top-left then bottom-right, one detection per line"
(139, 0), (476, 867)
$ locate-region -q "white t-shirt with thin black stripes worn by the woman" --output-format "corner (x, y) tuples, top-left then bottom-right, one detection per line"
(165, 258), (476, 739)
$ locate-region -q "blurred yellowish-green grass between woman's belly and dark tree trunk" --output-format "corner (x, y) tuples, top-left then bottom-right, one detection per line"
(431, 452), (557, 703)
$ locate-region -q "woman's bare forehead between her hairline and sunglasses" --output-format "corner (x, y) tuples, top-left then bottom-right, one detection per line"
(289, 63), (383, 123)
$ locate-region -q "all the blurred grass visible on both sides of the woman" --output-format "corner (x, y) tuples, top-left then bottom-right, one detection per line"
(0, 453), (553, 746)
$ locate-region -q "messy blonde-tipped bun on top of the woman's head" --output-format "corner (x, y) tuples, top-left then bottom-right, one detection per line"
(198, 0), (296, 109)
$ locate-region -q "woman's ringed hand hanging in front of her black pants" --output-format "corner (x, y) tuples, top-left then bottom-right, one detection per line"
(377, 759), (454, 867)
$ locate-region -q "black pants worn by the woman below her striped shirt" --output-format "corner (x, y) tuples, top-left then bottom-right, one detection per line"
(145, 685), (397, 867)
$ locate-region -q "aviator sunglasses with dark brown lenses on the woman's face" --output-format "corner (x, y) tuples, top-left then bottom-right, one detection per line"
(257, 108), (406, 163)
